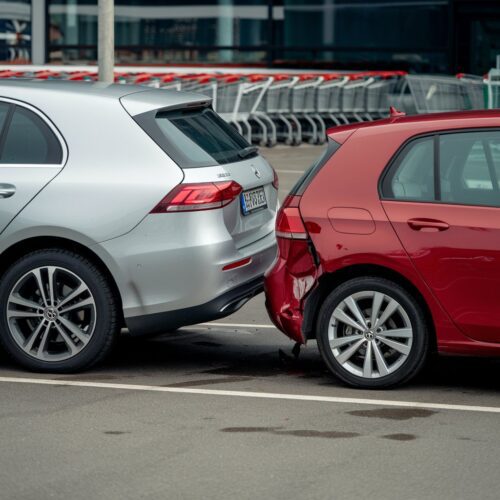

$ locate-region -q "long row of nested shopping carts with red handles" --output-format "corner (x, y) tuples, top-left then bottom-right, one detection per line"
(0, 68), (492, 146)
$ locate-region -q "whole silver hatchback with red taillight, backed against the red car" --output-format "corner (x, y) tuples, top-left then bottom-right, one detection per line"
(0, 80), (278, 372)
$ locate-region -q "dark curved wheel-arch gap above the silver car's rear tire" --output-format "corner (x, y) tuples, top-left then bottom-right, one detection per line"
(0, 236), (124, 324)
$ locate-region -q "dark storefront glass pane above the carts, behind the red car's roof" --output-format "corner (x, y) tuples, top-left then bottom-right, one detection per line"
(276, 0), (450, 72)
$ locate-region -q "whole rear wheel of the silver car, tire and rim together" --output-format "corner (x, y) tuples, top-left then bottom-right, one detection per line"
(0, 248), (120, 373)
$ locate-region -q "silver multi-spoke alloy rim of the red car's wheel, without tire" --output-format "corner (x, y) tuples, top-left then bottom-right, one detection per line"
(328, 291), (413, 379)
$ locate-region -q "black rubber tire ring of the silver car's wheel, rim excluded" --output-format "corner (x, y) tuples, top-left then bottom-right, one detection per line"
(0, 249), (116, 373)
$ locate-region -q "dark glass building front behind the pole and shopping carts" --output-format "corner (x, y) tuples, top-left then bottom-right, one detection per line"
(0, 0), (500, 74)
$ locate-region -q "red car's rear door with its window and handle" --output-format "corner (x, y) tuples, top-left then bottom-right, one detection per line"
(381, 130), (500, 342)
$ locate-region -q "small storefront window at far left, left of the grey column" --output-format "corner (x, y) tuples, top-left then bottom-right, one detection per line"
(0, 0), (31, 63)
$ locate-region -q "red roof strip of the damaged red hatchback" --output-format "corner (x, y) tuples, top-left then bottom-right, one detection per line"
(327, 109), (500, 143)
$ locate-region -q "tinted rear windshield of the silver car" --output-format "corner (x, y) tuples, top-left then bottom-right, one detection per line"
(141, 108), (257, 168)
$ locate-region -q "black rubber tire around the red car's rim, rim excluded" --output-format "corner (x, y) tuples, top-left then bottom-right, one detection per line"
(316, 277), (429, 389)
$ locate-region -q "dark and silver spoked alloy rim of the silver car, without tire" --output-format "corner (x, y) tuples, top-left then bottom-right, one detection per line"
(6, 266), (96, 362)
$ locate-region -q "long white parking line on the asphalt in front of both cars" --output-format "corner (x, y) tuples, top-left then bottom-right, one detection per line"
(0, 377), (500, 413)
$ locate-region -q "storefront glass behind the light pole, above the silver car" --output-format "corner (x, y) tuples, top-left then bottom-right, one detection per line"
(49, 0), (270, 64)
